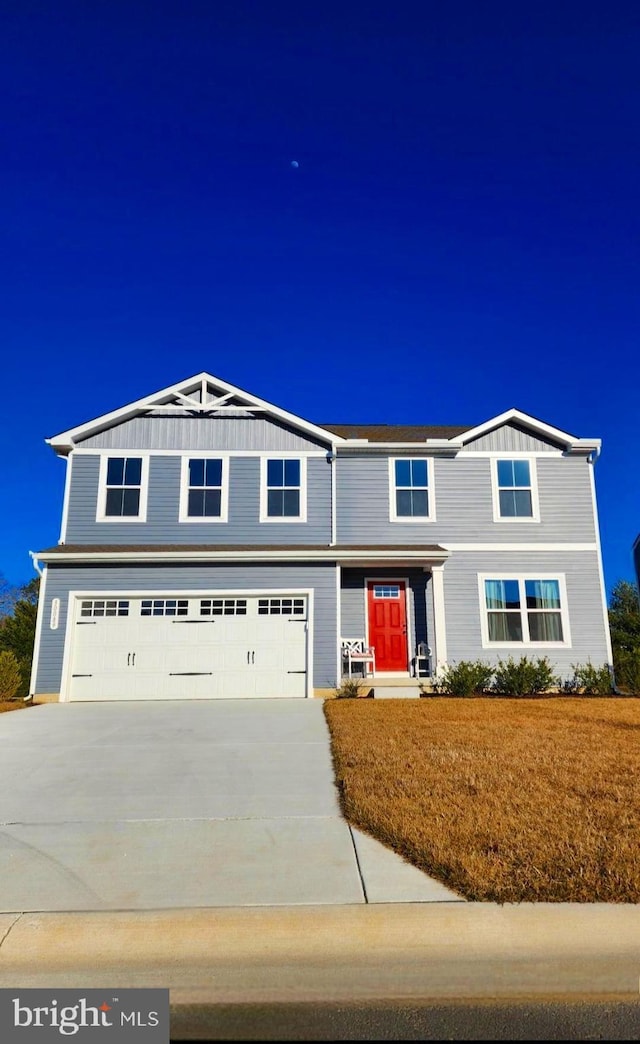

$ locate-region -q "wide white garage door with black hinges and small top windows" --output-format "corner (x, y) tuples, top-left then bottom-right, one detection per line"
(68, 593), (308, 701)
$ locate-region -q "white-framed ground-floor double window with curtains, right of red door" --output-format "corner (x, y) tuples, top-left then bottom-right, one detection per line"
(483, 577), (565, 644)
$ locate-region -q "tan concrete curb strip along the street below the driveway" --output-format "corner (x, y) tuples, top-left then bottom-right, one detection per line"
(0, 903), (640, 1007)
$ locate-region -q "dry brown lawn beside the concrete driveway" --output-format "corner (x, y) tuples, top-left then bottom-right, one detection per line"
(325, 697), (640, 903)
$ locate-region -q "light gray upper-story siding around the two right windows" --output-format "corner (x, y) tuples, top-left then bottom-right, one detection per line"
(336, 453), (596, 545)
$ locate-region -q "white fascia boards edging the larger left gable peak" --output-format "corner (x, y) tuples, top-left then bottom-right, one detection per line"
(45, 372), (343, 453)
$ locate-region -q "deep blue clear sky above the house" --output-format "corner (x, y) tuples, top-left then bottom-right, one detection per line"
(0, 0), (640, 587)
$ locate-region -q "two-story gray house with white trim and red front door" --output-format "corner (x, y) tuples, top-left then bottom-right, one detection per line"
(31, 373), (612, 701)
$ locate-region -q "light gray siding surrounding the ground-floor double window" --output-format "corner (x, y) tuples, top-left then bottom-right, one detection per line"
(444, 551), (609, 678)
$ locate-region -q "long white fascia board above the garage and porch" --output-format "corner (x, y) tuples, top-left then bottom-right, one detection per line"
(34, 545), (449, 565)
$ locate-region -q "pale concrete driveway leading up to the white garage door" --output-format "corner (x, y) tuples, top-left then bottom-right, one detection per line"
(0, 699), (459, 912)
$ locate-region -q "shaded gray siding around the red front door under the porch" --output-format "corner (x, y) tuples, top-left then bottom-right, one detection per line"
(340, 567), (428, 657)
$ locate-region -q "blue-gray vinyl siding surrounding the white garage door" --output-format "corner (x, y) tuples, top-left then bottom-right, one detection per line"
(34, 563), (337, 693)
